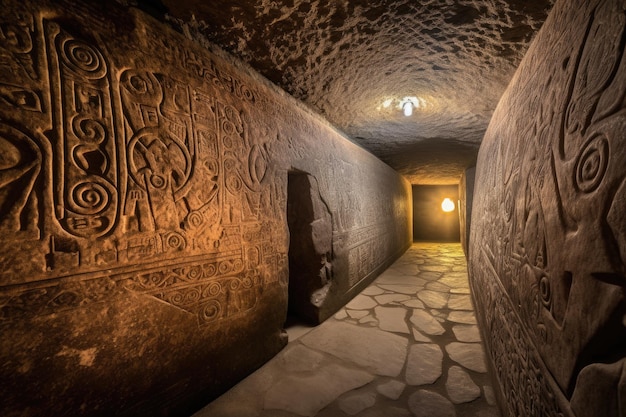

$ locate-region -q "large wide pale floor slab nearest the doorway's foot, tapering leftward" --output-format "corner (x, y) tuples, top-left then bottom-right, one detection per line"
(300, 322), (409, 377)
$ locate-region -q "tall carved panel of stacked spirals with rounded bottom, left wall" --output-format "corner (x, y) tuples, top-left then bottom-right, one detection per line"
(45, 22), (123, 238)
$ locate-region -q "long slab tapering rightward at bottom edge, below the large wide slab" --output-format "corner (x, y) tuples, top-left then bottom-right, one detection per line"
(264, 364), (374, 416)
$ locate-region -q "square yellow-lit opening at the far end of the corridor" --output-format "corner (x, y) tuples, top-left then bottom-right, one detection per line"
(413, 185), (461, 242)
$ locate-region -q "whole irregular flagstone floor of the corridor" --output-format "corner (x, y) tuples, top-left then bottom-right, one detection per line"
(194, 243), (500, 417)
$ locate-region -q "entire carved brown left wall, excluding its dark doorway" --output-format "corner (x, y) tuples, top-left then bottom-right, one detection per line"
(0, 0), (412, 416)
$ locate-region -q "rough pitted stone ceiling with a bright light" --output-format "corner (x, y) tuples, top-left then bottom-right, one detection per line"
(163, 0), (553, 184)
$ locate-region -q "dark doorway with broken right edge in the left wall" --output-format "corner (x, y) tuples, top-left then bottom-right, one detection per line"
(286, 171), (332, 326)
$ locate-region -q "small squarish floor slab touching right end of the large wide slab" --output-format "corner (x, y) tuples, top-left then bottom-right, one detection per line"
(406, 343), (443, 385)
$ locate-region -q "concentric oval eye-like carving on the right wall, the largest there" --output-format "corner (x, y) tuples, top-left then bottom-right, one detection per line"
(575, 135), (609, 193)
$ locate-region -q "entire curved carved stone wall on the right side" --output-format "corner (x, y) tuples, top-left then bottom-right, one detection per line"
(470, 0), (626, 417)
